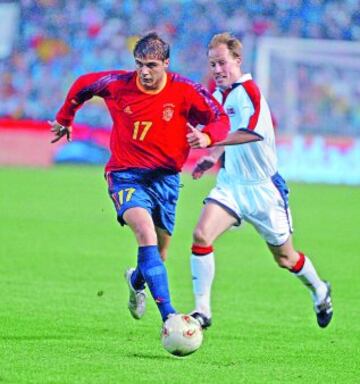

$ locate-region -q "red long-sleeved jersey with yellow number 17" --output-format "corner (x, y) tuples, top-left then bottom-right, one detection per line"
(56, 71), (229, 172)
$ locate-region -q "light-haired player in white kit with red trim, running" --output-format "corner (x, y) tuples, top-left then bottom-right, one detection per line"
(191, 33), (333, 328)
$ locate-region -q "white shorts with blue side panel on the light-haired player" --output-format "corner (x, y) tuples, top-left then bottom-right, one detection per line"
(205, 173), (293, 246)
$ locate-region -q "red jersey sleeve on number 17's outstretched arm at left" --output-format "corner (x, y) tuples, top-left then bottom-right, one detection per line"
(56, 71), (125, 126)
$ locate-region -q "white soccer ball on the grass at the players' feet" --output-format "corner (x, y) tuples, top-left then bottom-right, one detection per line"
(161, 314), (203, 356)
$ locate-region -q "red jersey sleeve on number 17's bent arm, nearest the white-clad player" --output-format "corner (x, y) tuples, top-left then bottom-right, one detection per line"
(189, 83), (230, 144)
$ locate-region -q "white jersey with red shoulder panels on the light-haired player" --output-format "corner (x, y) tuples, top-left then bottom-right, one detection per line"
(214, 74), (277, 184)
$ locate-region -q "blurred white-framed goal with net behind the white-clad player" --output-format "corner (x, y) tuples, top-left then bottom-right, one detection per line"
(255, 38), (360, 184)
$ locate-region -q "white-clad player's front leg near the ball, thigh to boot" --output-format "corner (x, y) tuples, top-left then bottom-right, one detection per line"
(191, 202), (237, 328)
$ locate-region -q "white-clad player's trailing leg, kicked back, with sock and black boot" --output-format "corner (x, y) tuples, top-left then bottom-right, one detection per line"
(268, 236), (333, 328)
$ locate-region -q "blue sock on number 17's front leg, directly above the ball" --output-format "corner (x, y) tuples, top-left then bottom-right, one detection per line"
(138, 245), (176, 321)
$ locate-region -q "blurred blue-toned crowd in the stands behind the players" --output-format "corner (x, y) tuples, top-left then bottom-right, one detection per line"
(0, 0), (360, 134)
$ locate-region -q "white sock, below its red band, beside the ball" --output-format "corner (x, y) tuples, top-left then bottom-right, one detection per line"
(191, 252), (215, 318)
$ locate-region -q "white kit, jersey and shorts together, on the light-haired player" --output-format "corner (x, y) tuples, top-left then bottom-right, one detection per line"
(205, 74), (292, 246)
